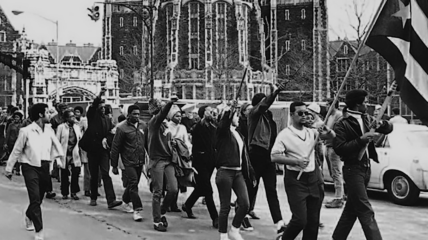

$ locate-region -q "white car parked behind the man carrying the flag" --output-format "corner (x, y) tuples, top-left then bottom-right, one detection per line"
(323, 124), (428, 205)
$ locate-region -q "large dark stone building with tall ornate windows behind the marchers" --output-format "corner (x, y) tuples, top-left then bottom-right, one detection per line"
(102, 0), (328, 100)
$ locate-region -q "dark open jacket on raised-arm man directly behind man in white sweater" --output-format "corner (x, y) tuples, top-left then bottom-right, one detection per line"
(248, 91), (278, 151)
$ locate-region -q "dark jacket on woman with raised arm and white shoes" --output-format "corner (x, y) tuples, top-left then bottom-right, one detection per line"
(215, 111), (255, 182)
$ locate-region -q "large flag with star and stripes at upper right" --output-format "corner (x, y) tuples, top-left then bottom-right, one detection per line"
(366, 0), (428, 121)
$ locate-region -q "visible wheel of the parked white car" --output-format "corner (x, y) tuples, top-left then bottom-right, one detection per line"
(387, 173), (420, 205)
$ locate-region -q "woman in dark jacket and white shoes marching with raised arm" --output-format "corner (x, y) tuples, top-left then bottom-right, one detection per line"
(215, 102), (256, 240)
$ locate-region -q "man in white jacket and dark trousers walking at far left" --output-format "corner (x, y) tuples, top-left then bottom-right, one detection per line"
(6, 103), (64, 240)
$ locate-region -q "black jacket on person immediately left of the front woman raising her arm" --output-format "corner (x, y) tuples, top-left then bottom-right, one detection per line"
(192, 120), (217, 169)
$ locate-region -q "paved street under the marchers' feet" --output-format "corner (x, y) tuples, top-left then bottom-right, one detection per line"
(0, 167), (428, 240)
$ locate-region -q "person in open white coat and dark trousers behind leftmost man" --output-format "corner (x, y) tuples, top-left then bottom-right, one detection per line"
(56, 110), (82, 200)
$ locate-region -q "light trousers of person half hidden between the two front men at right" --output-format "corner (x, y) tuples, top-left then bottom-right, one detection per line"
(326, 147), (344, 199)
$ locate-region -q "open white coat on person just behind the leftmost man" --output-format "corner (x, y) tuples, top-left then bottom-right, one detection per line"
(56, 123), (82, 169)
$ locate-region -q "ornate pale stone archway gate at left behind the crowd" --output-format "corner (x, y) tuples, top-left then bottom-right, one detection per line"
(23, 39), (119, 105)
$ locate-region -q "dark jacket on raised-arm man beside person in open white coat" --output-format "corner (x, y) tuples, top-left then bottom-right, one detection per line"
(85, 96), (114, 152)
